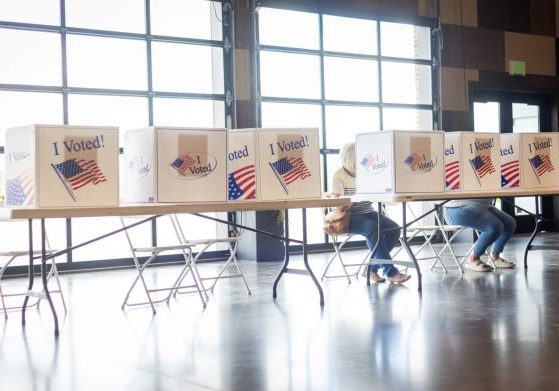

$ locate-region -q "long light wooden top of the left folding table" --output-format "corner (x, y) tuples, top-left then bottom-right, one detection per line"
(0, 197), (351, 219)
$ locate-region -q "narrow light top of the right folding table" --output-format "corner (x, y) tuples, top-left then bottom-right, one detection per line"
(351, 187), (559, 202)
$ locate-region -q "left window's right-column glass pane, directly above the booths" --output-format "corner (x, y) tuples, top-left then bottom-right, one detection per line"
(153, 98), (225, 128)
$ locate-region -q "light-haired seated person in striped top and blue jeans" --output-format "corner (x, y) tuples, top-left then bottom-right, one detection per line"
(330, 143), (411, 284)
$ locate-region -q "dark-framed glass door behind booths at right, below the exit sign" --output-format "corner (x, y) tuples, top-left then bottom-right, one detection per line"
(473, 91), (553, 233)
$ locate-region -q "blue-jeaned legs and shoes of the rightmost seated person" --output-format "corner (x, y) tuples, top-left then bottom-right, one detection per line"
(444, 199), (516, 272)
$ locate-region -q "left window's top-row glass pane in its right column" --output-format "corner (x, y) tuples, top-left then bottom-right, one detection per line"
(150, 0), (222, 41)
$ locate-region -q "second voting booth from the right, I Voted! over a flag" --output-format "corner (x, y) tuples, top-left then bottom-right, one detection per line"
(444, 132), (501, 191)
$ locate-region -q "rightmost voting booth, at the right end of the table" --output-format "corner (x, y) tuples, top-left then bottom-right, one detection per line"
(501, 132), (559, 189)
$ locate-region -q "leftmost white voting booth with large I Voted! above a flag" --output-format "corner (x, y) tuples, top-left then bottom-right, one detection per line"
(4, 125), (118, 208)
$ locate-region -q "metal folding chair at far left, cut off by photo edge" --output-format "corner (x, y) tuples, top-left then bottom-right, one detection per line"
(0, 220), (67, 319)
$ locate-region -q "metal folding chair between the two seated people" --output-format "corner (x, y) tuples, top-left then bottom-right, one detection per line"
(394, 204), (466, 273)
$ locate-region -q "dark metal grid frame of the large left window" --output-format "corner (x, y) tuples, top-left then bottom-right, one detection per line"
(0, 0), (235, 275)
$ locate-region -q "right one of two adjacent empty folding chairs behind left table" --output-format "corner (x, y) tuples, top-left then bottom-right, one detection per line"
(171, 215), (251, 298)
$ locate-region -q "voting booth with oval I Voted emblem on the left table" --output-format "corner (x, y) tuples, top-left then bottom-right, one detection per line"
(124, 126), (227, 202)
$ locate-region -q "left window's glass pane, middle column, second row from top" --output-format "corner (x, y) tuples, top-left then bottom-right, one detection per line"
(67, 34), (147, 90)
